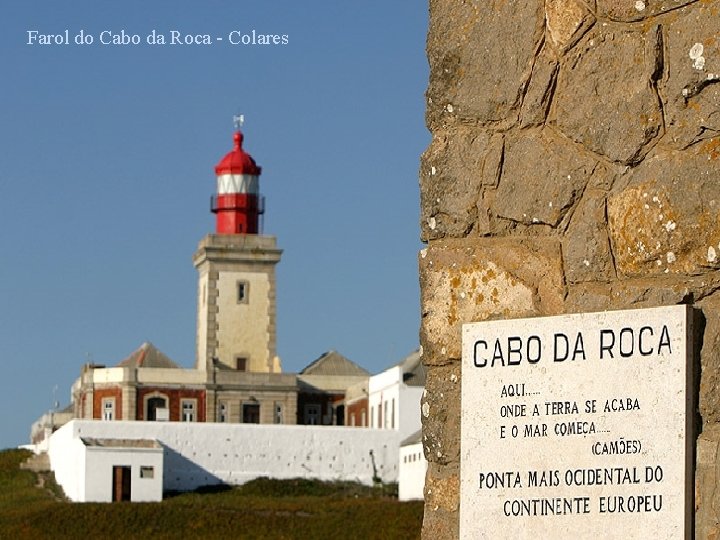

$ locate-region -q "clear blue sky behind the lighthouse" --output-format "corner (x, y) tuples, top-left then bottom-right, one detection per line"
(0, 0), (430, 448)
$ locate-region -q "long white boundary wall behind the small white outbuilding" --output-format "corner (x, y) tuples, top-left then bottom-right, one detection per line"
(49, 420), (401, 500)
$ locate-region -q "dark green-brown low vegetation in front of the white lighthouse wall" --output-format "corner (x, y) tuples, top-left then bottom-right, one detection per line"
(0, 450), (422, 539)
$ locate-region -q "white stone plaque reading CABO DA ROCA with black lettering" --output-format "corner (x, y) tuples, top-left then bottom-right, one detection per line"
(460, 306), (695, 540)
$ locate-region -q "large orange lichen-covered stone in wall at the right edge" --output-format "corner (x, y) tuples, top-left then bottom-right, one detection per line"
(608, 145), (720, 277)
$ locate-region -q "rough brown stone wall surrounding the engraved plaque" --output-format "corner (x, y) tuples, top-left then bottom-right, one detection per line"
(419, 0), (720, 538)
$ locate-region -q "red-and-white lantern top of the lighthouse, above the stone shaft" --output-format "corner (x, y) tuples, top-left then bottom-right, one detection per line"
(212, 130), (264, 234)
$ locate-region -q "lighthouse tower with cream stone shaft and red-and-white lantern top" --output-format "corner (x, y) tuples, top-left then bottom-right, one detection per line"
(193, 121), (282, 373)
